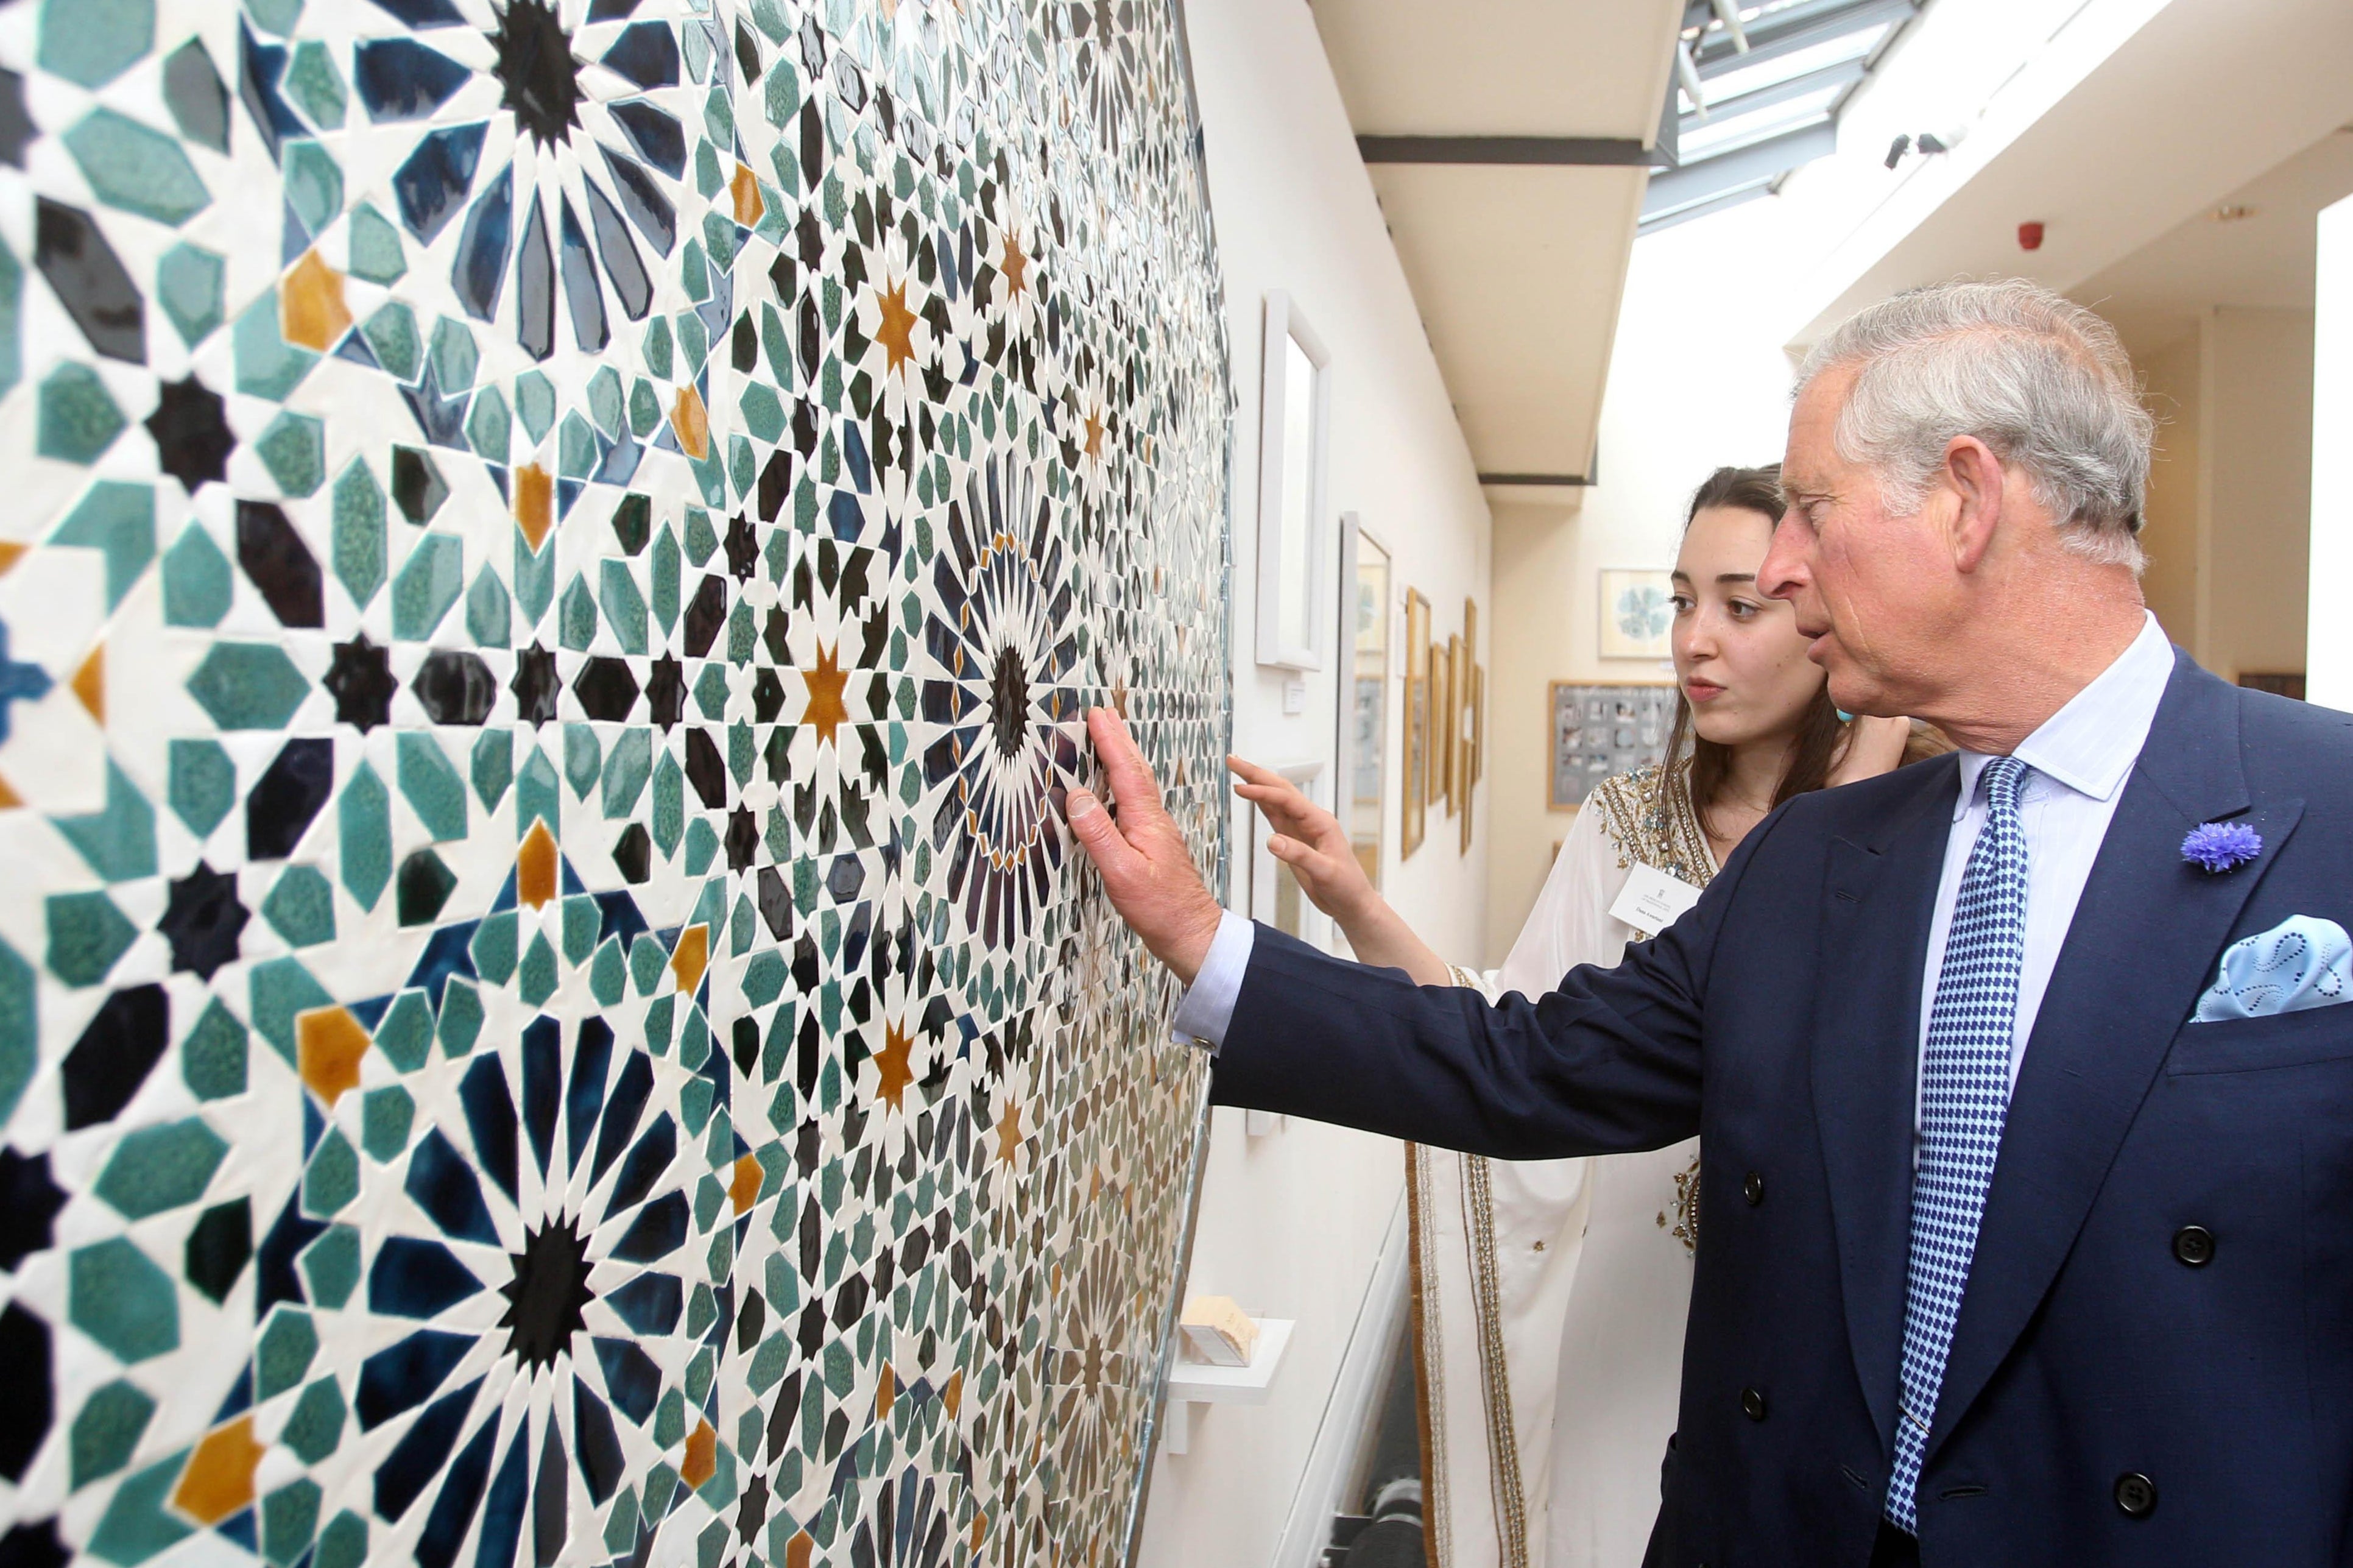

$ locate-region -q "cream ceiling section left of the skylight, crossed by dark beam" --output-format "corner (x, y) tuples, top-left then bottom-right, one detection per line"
(1308, 0), (1682, 495)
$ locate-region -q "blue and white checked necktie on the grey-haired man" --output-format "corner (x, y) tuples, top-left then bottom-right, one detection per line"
(1887, 756), (2031, 1533)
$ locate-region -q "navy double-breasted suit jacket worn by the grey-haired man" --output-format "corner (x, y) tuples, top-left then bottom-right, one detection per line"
(1214, 657), (2353, 1568)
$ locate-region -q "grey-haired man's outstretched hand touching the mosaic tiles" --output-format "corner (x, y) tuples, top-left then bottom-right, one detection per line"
(1064, 708), (1219, 984)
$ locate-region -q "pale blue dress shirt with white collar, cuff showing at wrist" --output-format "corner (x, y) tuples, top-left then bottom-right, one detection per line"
(1172, 615), (2174, 1083)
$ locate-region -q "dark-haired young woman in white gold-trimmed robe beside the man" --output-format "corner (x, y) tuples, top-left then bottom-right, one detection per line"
(1230, 468), (1946, 1568)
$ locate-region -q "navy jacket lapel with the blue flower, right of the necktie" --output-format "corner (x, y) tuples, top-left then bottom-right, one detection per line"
(1906, 657), (2304, 1455)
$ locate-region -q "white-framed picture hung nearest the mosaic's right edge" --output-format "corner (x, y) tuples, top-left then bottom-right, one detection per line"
(1259, 289), (1332, 669)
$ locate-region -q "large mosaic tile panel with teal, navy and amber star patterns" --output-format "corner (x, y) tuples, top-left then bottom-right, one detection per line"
(0, 0), (1228, 1568)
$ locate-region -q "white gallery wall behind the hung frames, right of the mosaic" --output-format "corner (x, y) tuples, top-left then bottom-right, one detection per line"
(1139, 0), (1492, 1568)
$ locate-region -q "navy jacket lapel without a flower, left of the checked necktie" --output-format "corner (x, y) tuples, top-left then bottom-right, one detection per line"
(1812, 760), (1960, 1443)
